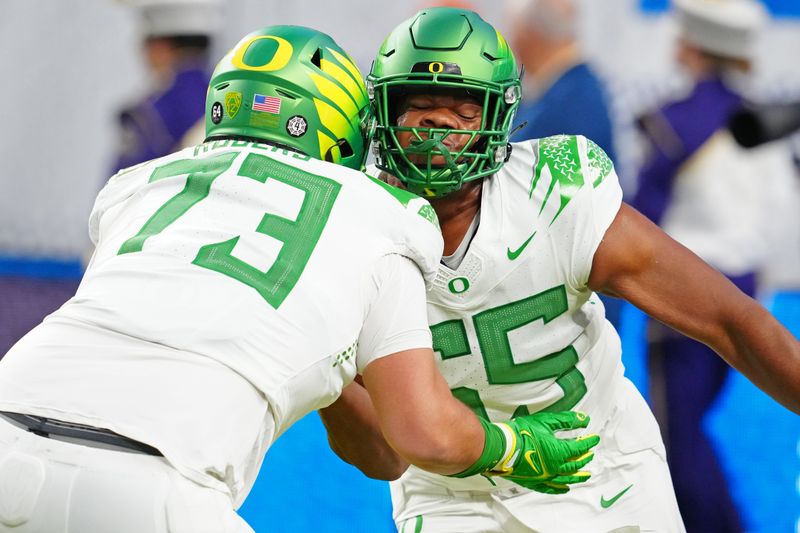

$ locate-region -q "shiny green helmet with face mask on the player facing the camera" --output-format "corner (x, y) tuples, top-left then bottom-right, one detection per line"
(367, 7), (521, 198)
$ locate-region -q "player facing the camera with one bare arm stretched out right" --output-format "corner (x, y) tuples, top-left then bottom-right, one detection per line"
(323, 8), (800, 533)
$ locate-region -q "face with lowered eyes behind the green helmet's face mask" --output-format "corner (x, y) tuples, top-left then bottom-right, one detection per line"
(397, 93), (483, 165)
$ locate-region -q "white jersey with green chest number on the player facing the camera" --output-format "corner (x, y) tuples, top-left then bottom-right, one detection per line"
(393, 135), (623, 492)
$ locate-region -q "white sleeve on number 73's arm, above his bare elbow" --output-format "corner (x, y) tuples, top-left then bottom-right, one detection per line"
(356, 254), (431, 372)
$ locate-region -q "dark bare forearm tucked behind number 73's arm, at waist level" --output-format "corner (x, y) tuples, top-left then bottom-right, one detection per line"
(319, 382), (408, 481)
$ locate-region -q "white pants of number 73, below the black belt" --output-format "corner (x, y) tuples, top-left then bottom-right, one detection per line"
(0, 418), (253, 533)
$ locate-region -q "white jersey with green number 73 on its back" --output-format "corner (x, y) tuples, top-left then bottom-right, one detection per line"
(0, 141), (442, 504)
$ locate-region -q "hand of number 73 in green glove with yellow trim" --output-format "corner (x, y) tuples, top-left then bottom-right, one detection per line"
(487, 411), (600, 494)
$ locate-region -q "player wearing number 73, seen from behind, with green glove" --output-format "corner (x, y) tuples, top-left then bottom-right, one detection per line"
(0, 26), (598, 533)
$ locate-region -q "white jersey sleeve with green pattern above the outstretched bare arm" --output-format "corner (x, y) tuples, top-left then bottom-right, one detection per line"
(570, 137), (622, 289)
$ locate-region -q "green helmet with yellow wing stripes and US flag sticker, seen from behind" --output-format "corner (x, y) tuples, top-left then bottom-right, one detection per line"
(206, 26), (372, 170)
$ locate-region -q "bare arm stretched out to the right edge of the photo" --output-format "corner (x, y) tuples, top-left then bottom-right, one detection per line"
(589, 204), (800, 413)
